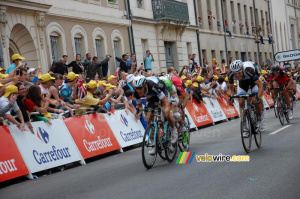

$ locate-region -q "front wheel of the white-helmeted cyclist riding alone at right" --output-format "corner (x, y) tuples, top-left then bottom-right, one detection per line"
(241, 110), (252, 153)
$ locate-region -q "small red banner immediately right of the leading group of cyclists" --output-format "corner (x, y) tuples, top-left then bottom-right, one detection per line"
(186, 99), (213, 127)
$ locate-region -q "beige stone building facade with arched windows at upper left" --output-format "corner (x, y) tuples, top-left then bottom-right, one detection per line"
(0, 0), (129, 73)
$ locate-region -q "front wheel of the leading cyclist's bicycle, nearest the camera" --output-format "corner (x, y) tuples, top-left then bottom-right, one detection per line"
(142, 124), (157, 169)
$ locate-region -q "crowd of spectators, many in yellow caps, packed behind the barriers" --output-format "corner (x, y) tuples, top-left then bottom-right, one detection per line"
(0, 50), (300, 133)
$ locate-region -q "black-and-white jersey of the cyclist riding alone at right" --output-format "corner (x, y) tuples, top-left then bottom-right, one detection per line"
(228, 62), (259, 91)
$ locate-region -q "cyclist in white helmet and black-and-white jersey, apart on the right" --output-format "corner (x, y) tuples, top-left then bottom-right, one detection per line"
(228, 60), (264, 133)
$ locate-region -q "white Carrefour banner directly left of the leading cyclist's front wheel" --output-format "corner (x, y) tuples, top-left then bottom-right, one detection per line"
(104, 110), (145, 148)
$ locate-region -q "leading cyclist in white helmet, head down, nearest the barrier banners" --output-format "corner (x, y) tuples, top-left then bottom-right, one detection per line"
(133, 76), (178, 155)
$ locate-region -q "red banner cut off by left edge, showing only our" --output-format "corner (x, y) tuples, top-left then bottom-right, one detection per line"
(0, 126), (30, 182)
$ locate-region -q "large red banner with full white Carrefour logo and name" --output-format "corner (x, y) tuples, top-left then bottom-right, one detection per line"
(64, 113), (120, 159)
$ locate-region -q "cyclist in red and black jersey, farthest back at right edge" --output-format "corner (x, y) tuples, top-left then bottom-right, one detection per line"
(268, 65), (293, 119)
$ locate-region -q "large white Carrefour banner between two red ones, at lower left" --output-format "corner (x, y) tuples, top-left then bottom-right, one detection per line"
(9, 119), (81, 173)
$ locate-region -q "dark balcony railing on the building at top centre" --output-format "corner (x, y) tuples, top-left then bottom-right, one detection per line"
(152, 0), (189, 23)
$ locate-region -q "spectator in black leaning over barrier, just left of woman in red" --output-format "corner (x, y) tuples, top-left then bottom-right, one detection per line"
(16, 82), (34, 134)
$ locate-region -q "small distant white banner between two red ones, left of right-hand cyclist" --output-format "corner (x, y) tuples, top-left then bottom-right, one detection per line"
(203, 97), (227, 122)
